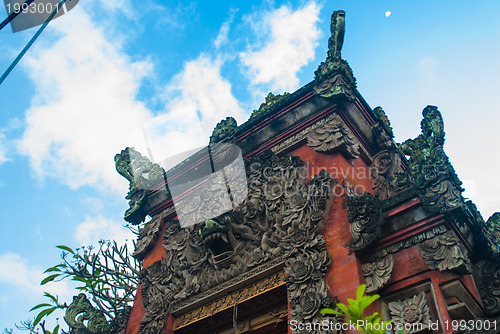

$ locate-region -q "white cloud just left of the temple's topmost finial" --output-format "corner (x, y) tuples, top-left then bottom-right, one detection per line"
(240, 2), (320, 92)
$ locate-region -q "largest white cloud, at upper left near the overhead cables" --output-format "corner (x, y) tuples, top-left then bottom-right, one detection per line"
(19, 9), (152, 192)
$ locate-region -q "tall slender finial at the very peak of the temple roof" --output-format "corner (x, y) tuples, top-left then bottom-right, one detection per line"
(313, 11), (356, 100)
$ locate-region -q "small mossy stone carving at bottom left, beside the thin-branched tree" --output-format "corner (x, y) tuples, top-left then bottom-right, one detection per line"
(64, 293), (111, 334)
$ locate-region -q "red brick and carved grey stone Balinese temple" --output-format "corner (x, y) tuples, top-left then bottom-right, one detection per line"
(64, 11), (500, 334)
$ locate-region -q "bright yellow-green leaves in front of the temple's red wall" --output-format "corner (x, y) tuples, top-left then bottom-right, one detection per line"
(320, 284), (403, 334)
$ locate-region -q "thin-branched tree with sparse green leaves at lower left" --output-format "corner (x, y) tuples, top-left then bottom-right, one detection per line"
(3, 241), (140, 334)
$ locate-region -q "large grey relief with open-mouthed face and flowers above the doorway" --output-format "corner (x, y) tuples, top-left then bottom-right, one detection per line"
(139, 155), (333, 333)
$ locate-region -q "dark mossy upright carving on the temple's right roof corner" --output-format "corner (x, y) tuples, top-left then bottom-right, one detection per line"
(400, 106), (464, 212)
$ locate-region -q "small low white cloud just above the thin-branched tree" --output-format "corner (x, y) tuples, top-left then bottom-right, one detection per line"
(75, 215), (135, 246)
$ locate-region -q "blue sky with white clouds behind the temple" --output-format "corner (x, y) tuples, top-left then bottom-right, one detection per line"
(0, 0), (500, 329)
